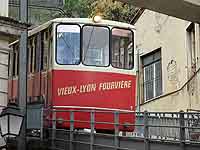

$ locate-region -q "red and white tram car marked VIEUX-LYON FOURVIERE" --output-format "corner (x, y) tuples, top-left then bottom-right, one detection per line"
(9, 18), (136, 131)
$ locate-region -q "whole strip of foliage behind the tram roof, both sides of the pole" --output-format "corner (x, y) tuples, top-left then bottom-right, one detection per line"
(10, 0), (136, 25)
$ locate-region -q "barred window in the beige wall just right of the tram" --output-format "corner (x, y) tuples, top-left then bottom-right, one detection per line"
(142, 49), (162, 102)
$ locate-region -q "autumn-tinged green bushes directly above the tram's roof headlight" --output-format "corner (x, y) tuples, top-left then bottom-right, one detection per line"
(63, 0), (135, 22)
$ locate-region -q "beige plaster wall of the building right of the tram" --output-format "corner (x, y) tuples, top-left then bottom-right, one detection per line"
(135, 10), (200, 111)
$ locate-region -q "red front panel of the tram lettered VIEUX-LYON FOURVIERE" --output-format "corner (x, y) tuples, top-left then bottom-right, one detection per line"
(53, 70), (136, 130)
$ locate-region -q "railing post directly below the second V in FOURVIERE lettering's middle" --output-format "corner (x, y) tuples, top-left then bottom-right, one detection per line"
(114, 111), (120, 150)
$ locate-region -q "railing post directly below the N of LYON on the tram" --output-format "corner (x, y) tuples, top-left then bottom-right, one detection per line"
(90, 111), (95, 150)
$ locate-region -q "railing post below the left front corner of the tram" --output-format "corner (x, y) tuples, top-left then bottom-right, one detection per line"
(51, 110), (56, 149)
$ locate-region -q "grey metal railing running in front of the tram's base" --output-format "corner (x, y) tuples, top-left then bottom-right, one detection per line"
(45, 109), (200, 150)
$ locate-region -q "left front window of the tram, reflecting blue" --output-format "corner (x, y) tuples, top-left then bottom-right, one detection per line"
(56, 25), (80, 65)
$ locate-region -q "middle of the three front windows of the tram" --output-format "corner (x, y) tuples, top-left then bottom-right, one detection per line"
(82, 26), (109, 66)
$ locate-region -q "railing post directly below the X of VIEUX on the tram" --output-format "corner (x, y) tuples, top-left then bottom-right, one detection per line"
(69, 110), (74, 150)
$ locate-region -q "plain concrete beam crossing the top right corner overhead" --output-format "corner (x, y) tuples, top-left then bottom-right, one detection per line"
(118, 0), (200, 23)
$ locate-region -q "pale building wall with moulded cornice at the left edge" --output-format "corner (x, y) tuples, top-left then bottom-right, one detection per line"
(0, 16), (25, 106)
